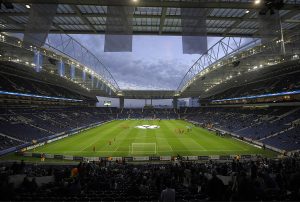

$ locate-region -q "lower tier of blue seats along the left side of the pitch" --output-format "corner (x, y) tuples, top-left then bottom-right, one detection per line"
(0, 107), (115, 148)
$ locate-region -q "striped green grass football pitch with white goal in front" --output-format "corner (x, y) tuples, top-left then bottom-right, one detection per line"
(31, 120), (275, 157)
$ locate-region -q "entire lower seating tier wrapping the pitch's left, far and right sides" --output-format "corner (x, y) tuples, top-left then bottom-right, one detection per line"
(0, 107), (300, 151)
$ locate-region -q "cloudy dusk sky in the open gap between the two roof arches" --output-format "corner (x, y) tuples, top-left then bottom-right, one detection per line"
(72, 35), (220, 90)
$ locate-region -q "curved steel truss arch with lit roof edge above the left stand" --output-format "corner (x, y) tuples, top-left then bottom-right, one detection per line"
(0, 33), (120, 92)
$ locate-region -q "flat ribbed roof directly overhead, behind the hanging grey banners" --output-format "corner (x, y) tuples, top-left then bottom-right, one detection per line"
(0, 0), (300, 37)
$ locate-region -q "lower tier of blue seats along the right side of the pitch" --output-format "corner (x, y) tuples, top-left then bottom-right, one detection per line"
(185, 107), (300, 151)
